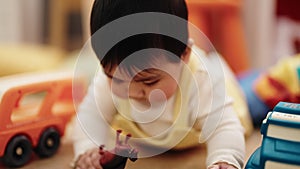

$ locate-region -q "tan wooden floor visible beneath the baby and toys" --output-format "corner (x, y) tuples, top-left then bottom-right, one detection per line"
(0, 130), (261, 169)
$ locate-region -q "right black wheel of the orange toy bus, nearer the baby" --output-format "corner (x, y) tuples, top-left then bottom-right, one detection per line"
(36, 128), (60, 157)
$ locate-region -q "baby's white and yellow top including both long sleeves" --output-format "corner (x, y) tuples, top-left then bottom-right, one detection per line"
(74, 47), (252, 168)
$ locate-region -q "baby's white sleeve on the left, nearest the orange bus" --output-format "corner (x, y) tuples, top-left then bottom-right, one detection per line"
(73, 72), (115, 159)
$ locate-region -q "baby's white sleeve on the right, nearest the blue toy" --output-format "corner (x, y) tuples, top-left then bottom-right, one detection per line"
(190, 68), (245, 169)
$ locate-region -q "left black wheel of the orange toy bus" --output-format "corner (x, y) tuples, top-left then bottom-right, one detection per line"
(3, 136), (32, 167)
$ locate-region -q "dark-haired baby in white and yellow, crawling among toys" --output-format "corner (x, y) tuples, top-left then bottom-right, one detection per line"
(74, 0), (250, 169)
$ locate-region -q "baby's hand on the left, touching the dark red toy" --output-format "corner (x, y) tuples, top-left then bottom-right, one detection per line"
(74, 148), (102, 169)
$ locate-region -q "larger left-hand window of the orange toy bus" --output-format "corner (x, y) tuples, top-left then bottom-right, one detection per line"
(11, 91), (47, 122)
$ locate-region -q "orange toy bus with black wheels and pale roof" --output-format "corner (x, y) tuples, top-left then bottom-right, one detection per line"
(0, 73), (84, 167)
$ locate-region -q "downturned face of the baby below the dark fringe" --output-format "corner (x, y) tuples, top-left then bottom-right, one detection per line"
(104, 61), (182, 105)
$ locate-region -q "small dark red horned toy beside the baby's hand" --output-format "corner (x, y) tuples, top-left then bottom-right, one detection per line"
(99, 130), (138, 169)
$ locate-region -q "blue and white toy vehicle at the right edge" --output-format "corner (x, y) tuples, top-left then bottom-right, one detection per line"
(245, 102), (300, 169)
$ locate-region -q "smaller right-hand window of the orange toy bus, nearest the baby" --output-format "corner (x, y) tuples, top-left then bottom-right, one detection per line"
(52, 85), (74, 114)
